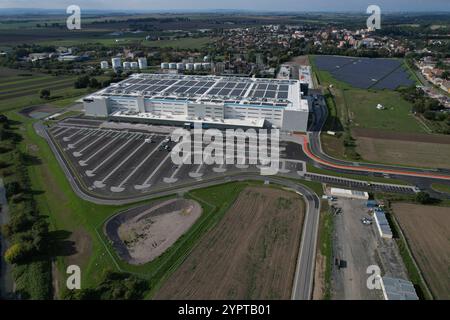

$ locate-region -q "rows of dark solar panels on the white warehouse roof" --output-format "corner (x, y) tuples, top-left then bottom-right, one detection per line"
(104, 74), (294, 103)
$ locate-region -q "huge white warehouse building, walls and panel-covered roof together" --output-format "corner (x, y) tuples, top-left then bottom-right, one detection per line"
(84, 74), (309, 131)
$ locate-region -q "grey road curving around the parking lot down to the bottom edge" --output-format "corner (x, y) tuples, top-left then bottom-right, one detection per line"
(34, 122), (320, 300)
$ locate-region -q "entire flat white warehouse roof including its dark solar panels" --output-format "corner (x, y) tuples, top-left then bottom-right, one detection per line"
(87, 74), (308, 111)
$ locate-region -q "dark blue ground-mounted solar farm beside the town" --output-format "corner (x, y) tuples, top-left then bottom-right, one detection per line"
(314, 56), (414, 90)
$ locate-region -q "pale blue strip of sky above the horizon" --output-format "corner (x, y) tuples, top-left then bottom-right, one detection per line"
(0, 0), (450, 12)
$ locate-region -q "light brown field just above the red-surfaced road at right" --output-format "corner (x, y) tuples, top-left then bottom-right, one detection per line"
(356, 137), (450, 169)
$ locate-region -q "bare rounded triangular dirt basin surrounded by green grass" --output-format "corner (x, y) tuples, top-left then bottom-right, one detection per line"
(105, 199), (202, 265)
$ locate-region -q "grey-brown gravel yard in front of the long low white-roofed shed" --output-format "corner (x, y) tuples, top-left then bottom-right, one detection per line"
(328, 191), (408, 300)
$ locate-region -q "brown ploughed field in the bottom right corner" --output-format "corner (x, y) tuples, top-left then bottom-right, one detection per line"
(392, 203), (450, 300)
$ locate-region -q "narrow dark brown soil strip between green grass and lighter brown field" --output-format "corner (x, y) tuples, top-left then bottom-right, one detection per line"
(352, 128), (450, 144)
